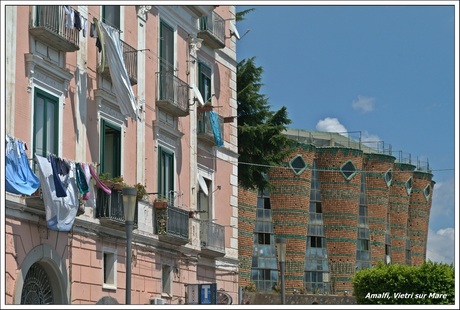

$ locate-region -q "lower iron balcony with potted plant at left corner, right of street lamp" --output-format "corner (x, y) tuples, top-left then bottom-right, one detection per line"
(155, 203), (189, 245)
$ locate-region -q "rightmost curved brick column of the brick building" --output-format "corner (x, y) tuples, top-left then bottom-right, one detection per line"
(409, 171), (434, 266)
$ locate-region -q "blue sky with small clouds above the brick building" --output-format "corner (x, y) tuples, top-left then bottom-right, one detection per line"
(236, 1), (458, 263)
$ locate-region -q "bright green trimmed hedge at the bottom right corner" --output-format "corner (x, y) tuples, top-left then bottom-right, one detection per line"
(352, 261), (455, 305)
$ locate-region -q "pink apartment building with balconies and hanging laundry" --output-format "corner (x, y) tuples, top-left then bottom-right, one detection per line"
(3, 5), (239, 305)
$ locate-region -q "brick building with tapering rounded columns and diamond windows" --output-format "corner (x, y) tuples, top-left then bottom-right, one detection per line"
(238, 129), (435, 295)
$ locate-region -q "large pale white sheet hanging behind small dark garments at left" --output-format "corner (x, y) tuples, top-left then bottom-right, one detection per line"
(35, 154), (79, 231)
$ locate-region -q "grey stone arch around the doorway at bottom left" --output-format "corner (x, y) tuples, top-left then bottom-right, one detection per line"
(14, 244), (70, 305)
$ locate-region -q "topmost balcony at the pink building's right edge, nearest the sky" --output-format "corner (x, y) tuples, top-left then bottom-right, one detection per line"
(197, 11), (225, 49)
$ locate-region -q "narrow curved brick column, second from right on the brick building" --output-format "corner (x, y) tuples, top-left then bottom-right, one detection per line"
(389, 163), (415, 264)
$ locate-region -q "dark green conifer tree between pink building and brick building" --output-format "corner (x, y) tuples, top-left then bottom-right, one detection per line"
(237, 57), (292, 190)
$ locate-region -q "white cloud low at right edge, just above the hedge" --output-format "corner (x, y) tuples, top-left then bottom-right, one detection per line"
(426, 227), (455, 264)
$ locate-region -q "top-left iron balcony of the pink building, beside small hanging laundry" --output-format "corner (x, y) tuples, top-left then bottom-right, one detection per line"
(29, 5), (80, 52)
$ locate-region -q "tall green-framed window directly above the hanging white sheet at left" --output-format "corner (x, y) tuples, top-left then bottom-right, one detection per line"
(33, 89), (59, 167)
